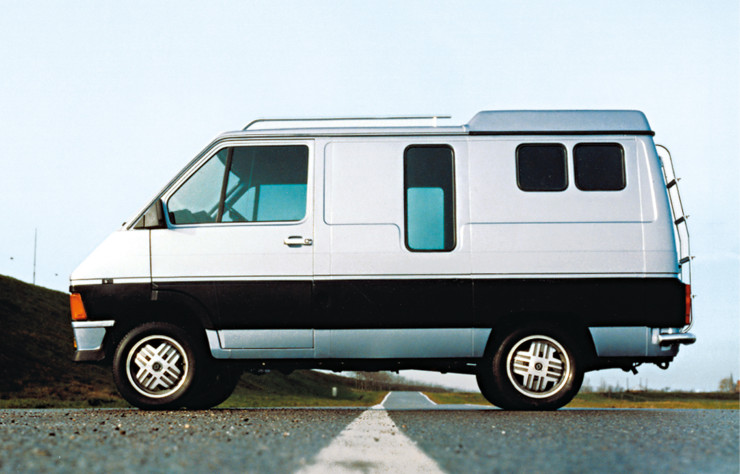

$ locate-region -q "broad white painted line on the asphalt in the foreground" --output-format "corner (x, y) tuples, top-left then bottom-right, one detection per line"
(298, 409), (443, 474)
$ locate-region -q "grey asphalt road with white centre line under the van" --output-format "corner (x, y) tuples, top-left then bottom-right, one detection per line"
(0, 392), (740, 473)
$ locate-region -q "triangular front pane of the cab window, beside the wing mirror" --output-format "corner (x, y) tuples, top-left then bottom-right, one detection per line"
(167, 150), (228, 224)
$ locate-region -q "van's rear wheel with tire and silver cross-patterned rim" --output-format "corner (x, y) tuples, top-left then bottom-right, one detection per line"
(477, 325), (583, 410)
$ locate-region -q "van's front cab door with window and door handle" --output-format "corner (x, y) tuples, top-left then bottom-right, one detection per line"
(151, 141), (313, 334)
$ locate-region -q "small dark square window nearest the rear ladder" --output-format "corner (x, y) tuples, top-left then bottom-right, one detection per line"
(573, 143), (627, 191)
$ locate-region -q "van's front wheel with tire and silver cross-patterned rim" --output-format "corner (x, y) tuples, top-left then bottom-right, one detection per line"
(113, 322), (210, 410)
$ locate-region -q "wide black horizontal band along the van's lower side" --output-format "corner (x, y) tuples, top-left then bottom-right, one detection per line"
(76, 278), (686, 329)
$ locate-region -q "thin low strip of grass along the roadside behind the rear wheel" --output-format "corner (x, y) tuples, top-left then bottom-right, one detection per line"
(426, 392), (740, 410)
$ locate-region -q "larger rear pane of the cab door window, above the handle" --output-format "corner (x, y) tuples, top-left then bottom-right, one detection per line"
(223, 146), (308, 222)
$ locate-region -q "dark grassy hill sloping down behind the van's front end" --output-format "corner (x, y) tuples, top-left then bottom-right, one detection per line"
(0, 275), (434, 408)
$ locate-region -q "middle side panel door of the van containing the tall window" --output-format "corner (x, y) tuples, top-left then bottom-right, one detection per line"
(314, 137), (473, 358)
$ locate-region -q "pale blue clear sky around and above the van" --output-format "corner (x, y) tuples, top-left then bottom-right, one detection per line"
(0, 0), (740, 390)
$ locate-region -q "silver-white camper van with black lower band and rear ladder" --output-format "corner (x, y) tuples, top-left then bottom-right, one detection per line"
(70, 110), (696, 410)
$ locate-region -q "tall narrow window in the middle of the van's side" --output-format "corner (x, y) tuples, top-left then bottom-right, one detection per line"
(404, 145), (455, 251)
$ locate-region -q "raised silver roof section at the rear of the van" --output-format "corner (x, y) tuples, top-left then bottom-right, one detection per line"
(465, 110), (654, 135)
